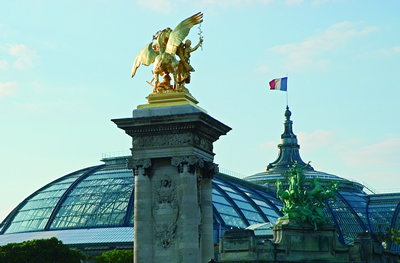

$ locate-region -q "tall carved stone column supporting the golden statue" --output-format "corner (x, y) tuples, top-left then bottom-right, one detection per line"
(112, 105), (231, 263)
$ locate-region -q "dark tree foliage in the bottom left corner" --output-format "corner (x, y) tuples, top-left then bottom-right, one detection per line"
(0, 237), (86, 263)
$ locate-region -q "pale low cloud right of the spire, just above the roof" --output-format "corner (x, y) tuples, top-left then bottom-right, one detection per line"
(282, 130), (400, 190)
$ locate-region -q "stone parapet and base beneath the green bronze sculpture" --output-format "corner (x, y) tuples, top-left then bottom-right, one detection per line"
(218, 221), (399, 263)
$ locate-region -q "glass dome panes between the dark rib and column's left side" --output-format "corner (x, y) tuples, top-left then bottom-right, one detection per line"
(50, 168), (134, 229)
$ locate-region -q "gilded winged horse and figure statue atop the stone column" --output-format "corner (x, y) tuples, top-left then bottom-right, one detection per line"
(131, 12), (203, 93)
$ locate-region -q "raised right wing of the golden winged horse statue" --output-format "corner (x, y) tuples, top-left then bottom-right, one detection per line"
(166, 12), (203, 55)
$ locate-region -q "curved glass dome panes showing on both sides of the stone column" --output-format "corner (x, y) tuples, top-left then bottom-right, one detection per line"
(0, 157), (282, 239)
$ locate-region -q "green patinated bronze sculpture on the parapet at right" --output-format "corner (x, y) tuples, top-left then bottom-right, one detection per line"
(276, 163), (338, 230)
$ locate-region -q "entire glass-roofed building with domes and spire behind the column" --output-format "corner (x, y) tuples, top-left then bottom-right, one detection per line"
(0, 108), (400, 258)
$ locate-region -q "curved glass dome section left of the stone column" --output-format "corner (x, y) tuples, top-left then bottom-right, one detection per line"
(2, 164), (134, 234)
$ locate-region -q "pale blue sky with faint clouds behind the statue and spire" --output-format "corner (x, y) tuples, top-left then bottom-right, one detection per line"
(0, 0), (400, 223)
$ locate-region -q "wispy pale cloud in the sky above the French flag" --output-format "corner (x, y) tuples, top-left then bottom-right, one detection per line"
(270, 21), (378, 71)
